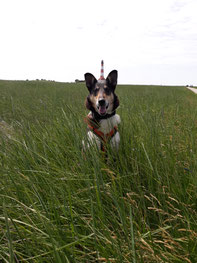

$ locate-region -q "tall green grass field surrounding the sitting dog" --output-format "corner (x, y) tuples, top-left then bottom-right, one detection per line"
(0, 81), (197, 263)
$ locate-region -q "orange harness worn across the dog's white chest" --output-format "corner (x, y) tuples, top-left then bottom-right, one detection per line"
(85, 117), (118, 152)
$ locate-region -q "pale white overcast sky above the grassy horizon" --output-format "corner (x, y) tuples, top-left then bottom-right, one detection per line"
(0, 0), (197, 85)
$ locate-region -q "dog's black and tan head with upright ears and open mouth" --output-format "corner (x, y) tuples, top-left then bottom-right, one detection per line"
(85, 70), (119, 116)
